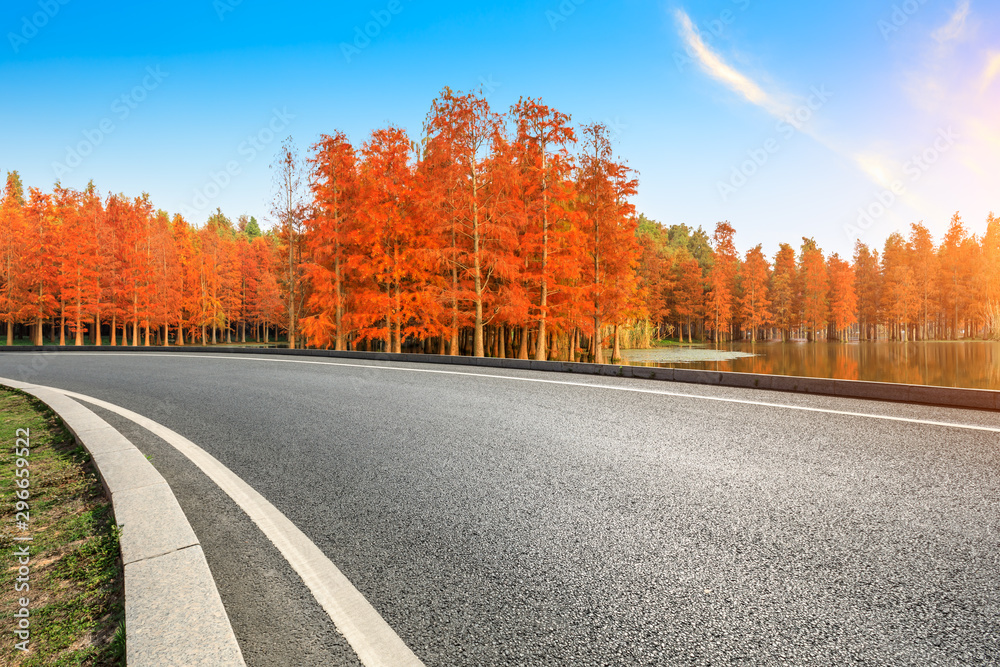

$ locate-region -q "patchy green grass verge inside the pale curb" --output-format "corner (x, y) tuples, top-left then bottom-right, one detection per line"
(0, 389), (125, 667)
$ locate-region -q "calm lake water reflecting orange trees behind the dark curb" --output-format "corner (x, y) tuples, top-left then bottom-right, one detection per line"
(622, 341), (1000, 389)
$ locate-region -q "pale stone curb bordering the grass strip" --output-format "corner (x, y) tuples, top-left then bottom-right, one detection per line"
(0, 378), (246, 667)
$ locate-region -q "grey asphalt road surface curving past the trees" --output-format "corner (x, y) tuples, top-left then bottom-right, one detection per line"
(0, 353), (1000, 667)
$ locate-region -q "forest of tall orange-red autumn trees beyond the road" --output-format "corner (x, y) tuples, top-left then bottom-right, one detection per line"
(0, 89), (1000, 363)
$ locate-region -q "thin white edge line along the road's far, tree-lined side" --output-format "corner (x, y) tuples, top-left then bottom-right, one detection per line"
(51, 352), (1000, 433)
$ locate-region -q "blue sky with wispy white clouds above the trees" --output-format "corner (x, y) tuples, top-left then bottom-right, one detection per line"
(0, 0), (1000, 255)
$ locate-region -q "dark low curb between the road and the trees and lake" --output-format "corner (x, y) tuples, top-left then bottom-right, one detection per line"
(0, 345), (1000, 410)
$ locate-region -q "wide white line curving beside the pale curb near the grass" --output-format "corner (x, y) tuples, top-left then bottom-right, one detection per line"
(46, 380), (423, 667)
